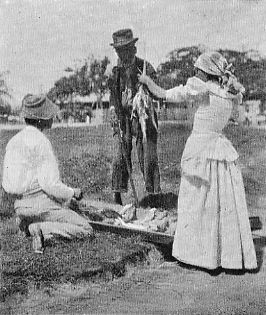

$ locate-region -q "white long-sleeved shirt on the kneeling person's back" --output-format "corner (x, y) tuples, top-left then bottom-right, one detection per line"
(2, 126), (74, 201)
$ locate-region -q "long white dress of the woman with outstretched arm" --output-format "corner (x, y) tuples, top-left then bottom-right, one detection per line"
(167, 77), (257, 269)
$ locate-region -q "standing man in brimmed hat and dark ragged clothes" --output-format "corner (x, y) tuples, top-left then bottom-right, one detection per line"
(109, 29), (161, 205)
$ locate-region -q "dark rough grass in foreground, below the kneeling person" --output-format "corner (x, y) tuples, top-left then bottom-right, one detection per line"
(2, 225), (150, 298)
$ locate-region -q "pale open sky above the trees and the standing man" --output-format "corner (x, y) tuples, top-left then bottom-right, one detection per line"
(0, 0), (266, 106)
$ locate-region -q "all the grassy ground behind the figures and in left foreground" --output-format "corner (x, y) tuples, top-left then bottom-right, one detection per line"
(0, 124), (266, 308)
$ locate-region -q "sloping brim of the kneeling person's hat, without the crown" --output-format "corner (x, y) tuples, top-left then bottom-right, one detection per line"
(21, 97), (60, 120)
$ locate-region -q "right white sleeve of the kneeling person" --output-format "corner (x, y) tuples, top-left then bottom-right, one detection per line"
(38, 141), (74, 200)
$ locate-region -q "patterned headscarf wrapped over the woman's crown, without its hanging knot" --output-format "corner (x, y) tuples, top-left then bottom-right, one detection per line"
(194, 51), (228, 76)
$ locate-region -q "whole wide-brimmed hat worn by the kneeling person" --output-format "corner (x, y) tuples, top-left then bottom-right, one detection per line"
(21, 94), (59, 120)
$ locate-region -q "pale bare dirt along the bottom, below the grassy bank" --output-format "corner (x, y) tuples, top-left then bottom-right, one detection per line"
(1, 249), (266, 315)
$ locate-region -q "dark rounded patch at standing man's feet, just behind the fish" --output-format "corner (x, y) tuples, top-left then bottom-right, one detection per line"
(139, 192), (178, 210)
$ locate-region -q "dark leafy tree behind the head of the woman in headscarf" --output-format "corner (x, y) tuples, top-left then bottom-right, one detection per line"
(158, 46), (266, 100)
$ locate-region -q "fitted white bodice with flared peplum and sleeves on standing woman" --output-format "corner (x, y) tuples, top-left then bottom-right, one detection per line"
(166, 77), (242, 181)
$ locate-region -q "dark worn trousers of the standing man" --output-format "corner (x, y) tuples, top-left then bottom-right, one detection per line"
(112, 112), (161, 193)
